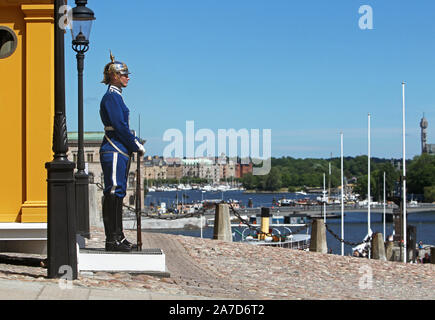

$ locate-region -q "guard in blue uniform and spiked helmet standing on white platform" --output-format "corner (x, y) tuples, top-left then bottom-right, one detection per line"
(100, 53), (145, 252)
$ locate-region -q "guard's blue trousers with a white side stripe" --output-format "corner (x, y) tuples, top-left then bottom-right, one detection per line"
(100, 152), (130, 198)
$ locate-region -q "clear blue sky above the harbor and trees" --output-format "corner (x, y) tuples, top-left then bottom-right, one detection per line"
(65, 0), (435, 158)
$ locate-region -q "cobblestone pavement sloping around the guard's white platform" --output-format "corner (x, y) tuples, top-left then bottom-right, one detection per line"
(0, 228), (435, 300)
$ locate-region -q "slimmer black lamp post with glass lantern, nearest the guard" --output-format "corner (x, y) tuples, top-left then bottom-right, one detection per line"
(71, 0), (95, 238)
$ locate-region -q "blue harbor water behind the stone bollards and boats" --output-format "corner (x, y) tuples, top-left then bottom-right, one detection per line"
(145, 190), (435, 255)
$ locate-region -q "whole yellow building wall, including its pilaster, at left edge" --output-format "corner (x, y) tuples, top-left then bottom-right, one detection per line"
(0, 0), (54, 222)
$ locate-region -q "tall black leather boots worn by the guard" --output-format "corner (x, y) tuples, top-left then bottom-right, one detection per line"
(103, 194), (131, 252)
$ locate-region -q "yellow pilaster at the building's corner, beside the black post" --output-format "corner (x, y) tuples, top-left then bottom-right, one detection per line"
(21, 4), (54, 222)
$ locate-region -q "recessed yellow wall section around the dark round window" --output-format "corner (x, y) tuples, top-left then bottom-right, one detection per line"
(0, 4), (25, 222)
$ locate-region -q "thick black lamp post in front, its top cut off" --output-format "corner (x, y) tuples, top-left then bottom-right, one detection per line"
(45, 0), (77, 280)
